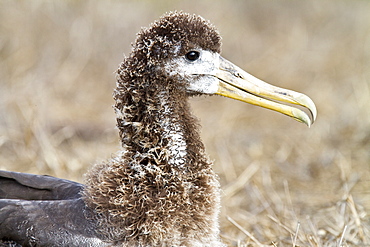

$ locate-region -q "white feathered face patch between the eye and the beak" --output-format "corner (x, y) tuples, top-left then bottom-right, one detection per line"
(164, 49), (220, 94)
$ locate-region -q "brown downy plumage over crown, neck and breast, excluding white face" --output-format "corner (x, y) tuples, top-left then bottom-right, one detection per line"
(84, 12), (222, 246)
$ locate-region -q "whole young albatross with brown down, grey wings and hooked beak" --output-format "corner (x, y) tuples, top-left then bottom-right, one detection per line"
(0, 12), (316, 247)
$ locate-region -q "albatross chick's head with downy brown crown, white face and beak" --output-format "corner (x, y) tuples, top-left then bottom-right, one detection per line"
(124, 12), (317, 126)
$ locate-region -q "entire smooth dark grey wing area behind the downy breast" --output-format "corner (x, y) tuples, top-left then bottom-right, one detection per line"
(0, 171), (106, 246)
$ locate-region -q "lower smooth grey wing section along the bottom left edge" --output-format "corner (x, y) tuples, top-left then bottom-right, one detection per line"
(0, 198), (106, 246)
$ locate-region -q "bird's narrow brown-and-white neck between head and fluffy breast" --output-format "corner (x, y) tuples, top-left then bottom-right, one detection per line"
(115, 83), (207, 171)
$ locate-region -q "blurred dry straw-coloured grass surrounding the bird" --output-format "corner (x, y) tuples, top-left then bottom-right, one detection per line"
(0, 0), (370, 246)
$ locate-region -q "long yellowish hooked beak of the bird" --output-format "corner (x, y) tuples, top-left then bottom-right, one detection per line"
(214, 56), (317, 127)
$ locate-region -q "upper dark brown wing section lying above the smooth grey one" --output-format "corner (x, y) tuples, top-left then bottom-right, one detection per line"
(0, 171), (83, 200)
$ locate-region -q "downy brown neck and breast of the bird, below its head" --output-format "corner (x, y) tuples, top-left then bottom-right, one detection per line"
(83, 75), (220, 243)
